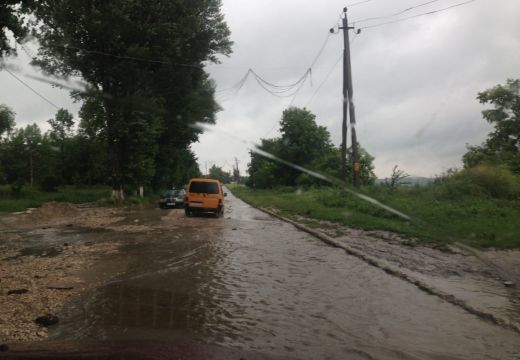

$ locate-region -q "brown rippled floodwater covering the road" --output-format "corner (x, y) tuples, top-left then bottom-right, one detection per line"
(49, 196), (520, 359)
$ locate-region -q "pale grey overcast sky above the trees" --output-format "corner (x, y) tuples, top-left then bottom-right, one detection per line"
(0, 0), (520, 177)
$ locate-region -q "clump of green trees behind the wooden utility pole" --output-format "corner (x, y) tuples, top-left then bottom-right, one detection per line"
(246, 107), (376, 188)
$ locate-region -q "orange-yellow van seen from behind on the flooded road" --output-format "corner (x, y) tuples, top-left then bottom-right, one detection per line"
(184, 178), (227, 217)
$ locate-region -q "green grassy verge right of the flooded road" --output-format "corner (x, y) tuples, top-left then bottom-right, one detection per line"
(229, 185), (520, 248)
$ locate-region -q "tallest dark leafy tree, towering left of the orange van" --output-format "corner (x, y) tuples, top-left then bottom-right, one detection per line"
(27, 0), (231, 200)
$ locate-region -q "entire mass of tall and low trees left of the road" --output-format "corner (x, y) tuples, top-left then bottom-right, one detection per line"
(0, 0), (232, 201)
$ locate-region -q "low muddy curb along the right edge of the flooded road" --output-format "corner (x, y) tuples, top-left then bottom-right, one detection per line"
(254, 207), (520, 334)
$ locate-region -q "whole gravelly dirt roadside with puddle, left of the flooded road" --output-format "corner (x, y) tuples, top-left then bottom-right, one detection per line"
(0, 203), (130, 343)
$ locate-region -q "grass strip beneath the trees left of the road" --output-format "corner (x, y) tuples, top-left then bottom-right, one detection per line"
(0, 186), (158, 212)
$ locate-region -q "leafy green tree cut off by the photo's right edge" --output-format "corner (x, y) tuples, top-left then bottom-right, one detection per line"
(463, 79), (520, 174)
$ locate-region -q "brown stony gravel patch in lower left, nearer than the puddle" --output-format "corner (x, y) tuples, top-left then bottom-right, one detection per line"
(0, 242), (118, 343)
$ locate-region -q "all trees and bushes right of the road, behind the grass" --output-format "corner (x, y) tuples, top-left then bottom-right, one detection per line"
(247, 79), (520, 199)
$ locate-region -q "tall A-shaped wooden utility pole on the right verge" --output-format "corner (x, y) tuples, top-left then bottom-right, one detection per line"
(331, 7), (360, 187)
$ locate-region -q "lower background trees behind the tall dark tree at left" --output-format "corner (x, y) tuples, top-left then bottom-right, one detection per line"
(0, 105), (200, 194)
